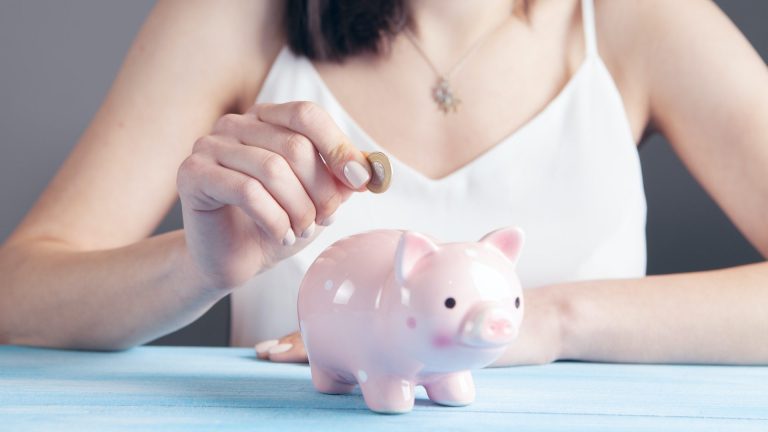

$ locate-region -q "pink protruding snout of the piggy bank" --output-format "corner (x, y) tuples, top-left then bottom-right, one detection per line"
(461, 305), (518, 348)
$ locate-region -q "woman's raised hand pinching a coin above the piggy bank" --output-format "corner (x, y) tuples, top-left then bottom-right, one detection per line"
(177, 102), (370, 289)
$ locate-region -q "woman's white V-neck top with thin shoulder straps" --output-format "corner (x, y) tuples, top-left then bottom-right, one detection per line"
(231, 0), (646, 346)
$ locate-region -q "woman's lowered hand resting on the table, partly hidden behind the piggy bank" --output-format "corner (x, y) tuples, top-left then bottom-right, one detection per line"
(254, 287), (563, 367)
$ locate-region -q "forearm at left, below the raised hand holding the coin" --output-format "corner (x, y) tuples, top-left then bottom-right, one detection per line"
(0, 231), (226, 349)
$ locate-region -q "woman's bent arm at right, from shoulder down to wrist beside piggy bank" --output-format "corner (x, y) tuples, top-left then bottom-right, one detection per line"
(497, 0), (768, 365)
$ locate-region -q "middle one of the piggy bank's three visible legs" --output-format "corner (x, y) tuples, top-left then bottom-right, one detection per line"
(358, 373), (416, 414)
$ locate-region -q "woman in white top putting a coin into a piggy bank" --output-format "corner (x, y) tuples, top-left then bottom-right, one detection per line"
(0, 0), (768, 365)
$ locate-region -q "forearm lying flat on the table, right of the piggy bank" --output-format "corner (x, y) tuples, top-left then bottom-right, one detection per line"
(553, 263), (768, 364)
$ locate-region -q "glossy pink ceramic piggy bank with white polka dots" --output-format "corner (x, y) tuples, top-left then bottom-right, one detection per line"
(298, 228), (523, 413)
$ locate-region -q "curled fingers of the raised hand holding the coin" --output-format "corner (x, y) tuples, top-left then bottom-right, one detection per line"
(189, 102), (370, 245)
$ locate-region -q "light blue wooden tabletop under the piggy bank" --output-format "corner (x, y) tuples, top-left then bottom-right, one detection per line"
(0, 346), (768, 432)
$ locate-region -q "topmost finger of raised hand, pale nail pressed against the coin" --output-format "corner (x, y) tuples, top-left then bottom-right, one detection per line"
(251, 102), (371, 190)
